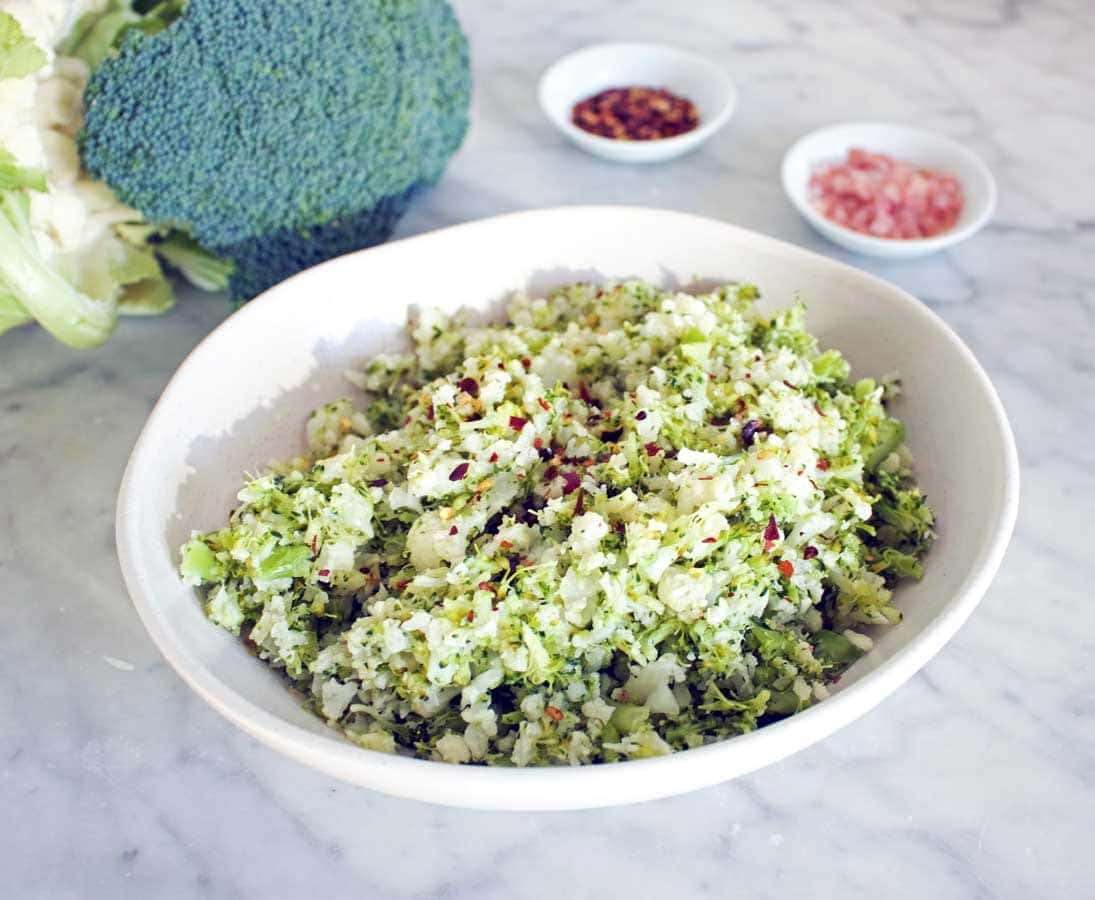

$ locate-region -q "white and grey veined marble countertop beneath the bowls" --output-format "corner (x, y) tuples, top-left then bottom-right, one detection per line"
(0, 0), (1095, 900)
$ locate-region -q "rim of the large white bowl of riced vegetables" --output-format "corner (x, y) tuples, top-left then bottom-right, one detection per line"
(115, 205), (1019, 810)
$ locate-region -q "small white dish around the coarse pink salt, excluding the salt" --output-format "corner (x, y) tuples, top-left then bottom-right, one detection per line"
(783, 122), (996, 259)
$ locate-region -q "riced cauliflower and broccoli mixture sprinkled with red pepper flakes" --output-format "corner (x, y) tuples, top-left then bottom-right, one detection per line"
(181, 281), (933, 765)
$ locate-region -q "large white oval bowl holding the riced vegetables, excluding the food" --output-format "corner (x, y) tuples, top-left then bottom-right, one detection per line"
(117, 207), (1018, 809)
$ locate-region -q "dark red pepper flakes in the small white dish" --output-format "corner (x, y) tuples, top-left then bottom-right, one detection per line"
(570, 88), (700, 140)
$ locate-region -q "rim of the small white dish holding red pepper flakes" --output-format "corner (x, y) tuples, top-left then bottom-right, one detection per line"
(537, 41), (738, 155)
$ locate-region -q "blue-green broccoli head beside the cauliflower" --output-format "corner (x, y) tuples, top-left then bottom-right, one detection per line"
(80, 0), (471, 299)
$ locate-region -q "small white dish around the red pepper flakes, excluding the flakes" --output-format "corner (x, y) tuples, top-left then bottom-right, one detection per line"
(540, 44), (737, 162)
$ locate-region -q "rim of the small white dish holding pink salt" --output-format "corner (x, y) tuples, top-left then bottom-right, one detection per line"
(780, 119), (998, 257)
